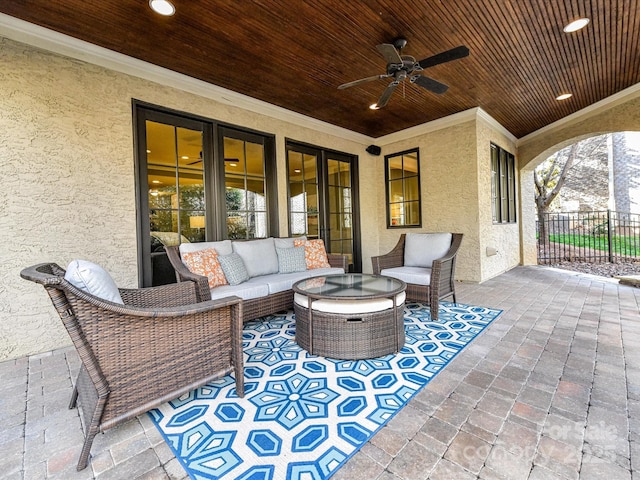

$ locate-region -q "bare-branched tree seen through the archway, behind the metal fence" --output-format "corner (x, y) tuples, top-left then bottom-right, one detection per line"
(533, 135), (608, 243)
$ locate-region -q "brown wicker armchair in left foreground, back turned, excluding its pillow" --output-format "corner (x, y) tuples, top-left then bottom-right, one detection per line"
(20, 263), (244, 470)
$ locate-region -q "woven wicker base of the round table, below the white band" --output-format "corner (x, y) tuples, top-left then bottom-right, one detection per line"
(293, 303), (405, 360)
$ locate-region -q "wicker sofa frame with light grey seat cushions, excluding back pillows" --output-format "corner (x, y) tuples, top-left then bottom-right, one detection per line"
(166, 239), (348, 322)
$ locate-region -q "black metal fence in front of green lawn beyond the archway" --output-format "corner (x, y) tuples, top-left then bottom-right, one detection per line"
(536, 210), (640, 263)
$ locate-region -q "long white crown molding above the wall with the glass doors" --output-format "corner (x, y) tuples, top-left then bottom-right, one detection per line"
(0, 13), (374, 145)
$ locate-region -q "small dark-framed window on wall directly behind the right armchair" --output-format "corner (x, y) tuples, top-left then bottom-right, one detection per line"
(384, 149), (422, 228)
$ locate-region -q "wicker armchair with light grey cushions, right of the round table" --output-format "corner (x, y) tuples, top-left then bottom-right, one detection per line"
(371, 233), (463, 320)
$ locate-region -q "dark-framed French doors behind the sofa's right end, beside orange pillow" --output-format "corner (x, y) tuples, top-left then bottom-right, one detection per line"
(287, 143), (362, 272)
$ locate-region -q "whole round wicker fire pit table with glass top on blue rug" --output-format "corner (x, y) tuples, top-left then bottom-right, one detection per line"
(293, 273), (407, 360)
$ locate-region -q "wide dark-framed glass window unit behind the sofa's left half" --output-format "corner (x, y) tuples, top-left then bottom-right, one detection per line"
(134, 102), (278, 287)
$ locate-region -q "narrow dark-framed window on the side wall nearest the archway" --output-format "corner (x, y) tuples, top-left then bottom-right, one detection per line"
(491, 143), (516, 223)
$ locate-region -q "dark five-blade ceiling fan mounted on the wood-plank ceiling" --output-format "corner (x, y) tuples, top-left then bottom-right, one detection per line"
(338, 38), (469, 108)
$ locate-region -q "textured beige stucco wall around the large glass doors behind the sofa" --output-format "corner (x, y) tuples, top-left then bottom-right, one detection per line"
(0, 38), (377, 360)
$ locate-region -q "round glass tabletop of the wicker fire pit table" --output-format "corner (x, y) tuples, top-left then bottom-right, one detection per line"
(293, 273), (407, 299)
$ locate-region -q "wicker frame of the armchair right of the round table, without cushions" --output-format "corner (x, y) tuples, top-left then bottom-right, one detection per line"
(371, 233), (463, 320)
